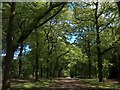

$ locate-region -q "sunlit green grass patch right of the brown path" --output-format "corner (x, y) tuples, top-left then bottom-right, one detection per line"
(80, 79), (120, 90)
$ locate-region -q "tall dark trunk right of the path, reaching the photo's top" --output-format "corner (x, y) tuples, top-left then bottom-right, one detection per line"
(95, 2), (103, 82)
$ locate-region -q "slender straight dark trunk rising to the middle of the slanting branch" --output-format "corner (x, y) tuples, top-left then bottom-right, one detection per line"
(35, 30), (39, 81)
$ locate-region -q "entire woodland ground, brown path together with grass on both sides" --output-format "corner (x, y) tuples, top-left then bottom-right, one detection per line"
(11, 77), (120, 90)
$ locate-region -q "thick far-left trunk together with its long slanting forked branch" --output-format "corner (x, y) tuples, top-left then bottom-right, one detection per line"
(2, 2), (64, 90)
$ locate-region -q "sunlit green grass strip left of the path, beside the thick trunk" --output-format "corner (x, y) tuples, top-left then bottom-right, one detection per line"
(12, 80), (55, 90)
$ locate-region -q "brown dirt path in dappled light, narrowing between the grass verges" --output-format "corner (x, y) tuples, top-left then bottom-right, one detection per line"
(48, 77), (95, 90)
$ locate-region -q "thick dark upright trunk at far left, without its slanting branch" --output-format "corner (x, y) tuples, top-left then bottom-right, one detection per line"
(2, 2), (16, 90)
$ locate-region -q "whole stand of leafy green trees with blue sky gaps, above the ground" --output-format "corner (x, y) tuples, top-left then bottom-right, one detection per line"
(2, 2), (120, 90)
